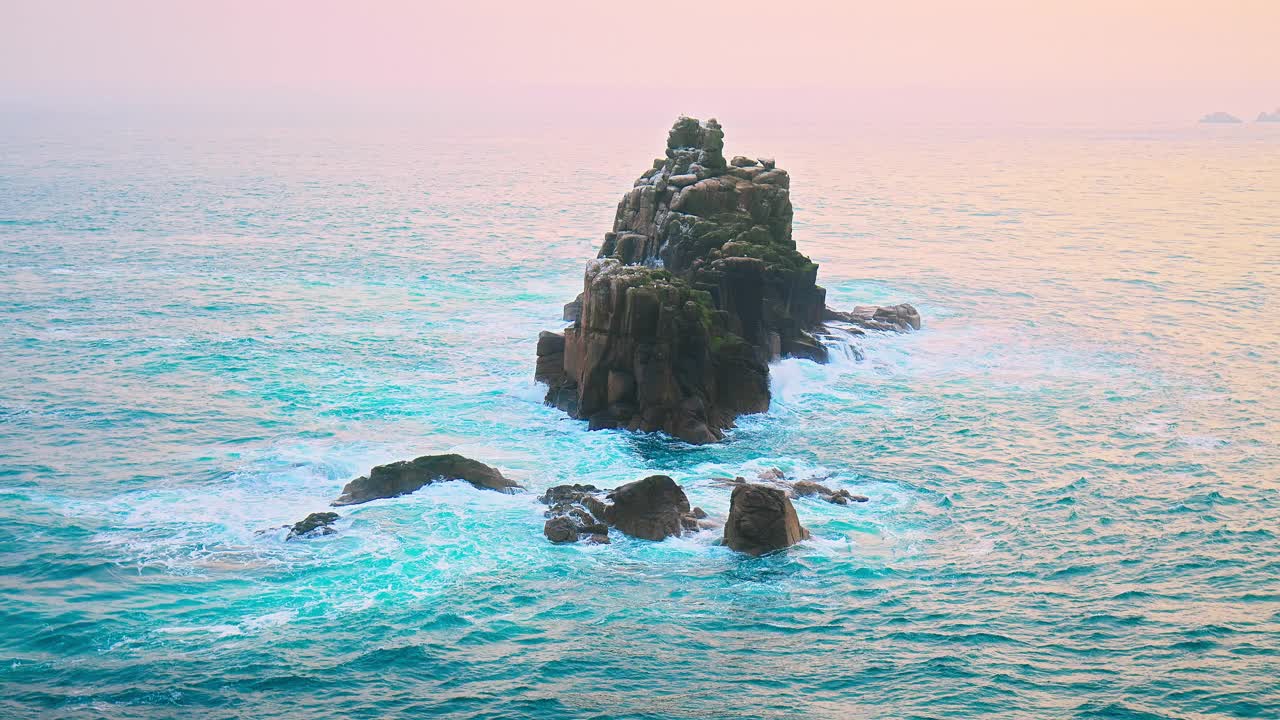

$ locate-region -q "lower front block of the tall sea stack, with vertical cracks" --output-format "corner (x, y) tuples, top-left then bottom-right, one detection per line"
(536, 259), (769, 443)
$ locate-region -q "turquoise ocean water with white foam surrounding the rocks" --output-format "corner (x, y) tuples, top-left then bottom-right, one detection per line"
(0, 118), (1280, 719)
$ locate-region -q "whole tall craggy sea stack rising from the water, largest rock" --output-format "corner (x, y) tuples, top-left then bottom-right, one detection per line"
(535, 118), (919, 443)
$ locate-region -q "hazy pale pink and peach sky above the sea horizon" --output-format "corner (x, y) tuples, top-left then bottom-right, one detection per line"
(0, 0), (1280, 122)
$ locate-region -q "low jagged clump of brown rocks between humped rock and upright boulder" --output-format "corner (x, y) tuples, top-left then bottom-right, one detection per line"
(539, 475), (707, 543)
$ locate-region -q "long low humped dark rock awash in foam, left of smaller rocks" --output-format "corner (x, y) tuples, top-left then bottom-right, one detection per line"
(330, 455), (520, 507)
